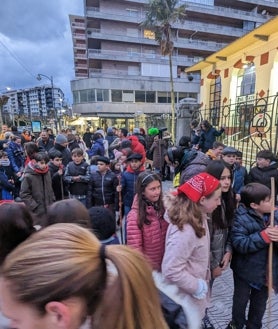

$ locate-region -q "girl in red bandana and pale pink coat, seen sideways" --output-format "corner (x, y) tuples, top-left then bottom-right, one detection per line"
(162, 173), (221, 328)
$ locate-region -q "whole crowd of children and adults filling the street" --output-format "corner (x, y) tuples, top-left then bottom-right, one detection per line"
(0, 120), (278, 329)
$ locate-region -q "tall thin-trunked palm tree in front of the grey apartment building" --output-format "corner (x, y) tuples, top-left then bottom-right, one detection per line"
(141, 0), (186, 141)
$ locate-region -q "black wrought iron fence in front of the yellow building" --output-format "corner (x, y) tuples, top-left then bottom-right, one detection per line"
(192, 93), (278, 168)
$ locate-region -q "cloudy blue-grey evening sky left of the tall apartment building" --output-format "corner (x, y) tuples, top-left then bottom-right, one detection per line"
(0, 0), (84, 104)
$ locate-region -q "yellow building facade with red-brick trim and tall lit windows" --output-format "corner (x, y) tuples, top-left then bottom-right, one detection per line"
(186, 17), (278, 166)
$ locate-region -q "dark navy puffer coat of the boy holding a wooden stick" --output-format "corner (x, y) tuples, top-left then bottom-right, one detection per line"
(231, 204), (278, 285)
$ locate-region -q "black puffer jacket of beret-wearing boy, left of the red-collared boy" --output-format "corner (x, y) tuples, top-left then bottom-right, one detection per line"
(86, 170), (119, 210)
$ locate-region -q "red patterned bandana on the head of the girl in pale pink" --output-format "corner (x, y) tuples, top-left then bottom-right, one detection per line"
(178, 172), (220, 202)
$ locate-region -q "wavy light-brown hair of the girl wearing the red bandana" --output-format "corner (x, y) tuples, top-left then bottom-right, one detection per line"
(163, 191), (206, 238)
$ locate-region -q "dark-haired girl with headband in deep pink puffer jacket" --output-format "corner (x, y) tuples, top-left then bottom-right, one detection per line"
(127, 172), (168, 271)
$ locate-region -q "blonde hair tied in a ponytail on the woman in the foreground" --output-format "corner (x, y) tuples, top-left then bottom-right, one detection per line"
(2, 224), (167, 329)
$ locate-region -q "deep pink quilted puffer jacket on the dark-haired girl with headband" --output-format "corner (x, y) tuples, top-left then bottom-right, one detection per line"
(127, 195), (168, 271)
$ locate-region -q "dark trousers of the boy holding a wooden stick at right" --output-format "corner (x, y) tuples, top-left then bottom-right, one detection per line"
(232, 273), (268, 329)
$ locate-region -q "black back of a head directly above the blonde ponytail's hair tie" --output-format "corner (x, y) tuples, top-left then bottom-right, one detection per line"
(89, 207), (116, 240)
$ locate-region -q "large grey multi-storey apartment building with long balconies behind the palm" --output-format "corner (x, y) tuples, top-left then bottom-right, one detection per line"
(70, 0), (278, 130)
